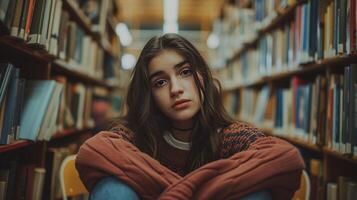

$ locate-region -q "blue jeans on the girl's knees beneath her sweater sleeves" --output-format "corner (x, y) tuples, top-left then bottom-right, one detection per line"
(90, 177), (272, 200)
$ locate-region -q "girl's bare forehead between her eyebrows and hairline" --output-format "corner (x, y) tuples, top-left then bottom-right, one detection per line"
(149, 50), (185, 74)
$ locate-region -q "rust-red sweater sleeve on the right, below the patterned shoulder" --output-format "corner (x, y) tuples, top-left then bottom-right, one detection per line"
(160, 137), (305, 200)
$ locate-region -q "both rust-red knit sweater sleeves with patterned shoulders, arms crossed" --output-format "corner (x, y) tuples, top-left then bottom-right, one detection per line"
(76, 123), (304, 200)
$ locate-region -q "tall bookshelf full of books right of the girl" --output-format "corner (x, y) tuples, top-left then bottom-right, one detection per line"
(216, 0), (357, 199)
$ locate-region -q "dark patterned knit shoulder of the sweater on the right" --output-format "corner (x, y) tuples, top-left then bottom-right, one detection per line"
(219, 122), (266, 158)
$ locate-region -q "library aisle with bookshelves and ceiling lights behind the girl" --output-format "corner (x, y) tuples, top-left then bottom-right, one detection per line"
(0, 0), (357, 200)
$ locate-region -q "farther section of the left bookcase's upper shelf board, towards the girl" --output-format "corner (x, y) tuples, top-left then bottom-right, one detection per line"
(52, 60), (114, 89)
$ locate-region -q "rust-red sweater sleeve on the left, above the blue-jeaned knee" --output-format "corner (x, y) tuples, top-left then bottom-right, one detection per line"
(76, 131), (181, 199)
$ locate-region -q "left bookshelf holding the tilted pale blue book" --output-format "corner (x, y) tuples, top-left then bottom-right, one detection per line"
(0, 0), (125, 199)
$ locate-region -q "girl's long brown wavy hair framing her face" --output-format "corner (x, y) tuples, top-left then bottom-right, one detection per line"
(112, 33), (233, 172)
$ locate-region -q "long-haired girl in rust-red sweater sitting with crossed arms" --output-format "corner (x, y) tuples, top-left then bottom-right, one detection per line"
(76, 34), (304, 199)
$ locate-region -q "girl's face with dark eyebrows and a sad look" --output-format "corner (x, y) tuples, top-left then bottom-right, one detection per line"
(149, 50), (202, 126)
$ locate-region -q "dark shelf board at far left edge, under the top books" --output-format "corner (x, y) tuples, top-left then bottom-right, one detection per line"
(0, 35), (55, 61)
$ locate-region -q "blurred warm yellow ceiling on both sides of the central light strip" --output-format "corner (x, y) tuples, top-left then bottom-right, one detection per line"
(117, 0), (224, 31)
